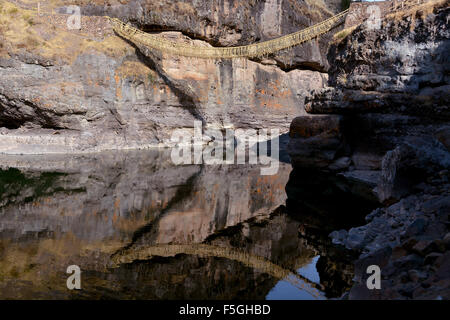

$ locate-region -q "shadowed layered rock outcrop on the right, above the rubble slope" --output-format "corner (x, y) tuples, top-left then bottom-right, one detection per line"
(289, 4), (450, 202)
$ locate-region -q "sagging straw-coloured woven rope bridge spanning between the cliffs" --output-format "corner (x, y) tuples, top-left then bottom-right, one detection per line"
(109, 9), (348, 59)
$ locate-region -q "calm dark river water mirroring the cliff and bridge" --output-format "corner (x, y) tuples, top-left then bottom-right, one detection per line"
(0, 151), (372, 299)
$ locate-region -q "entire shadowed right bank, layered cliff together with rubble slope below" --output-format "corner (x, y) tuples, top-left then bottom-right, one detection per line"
(289, 1), (450, 299)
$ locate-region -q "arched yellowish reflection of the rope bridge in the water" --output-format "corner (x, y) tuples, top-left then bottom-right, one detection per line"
(112, 244), (323, 298)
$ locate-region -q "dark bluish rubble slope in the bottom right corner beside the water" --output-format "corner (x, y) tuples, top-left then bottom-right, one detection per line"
(330, 186), (450, 299)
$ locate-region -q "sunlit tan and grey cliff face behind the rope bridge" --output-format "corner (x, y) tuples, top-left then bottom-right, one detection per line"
(0, 0), (338, 154)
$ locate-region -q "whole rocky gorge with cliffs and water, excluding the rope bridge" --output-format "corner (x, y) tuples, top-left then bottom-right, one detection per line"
(0, 0), (450, 300)
